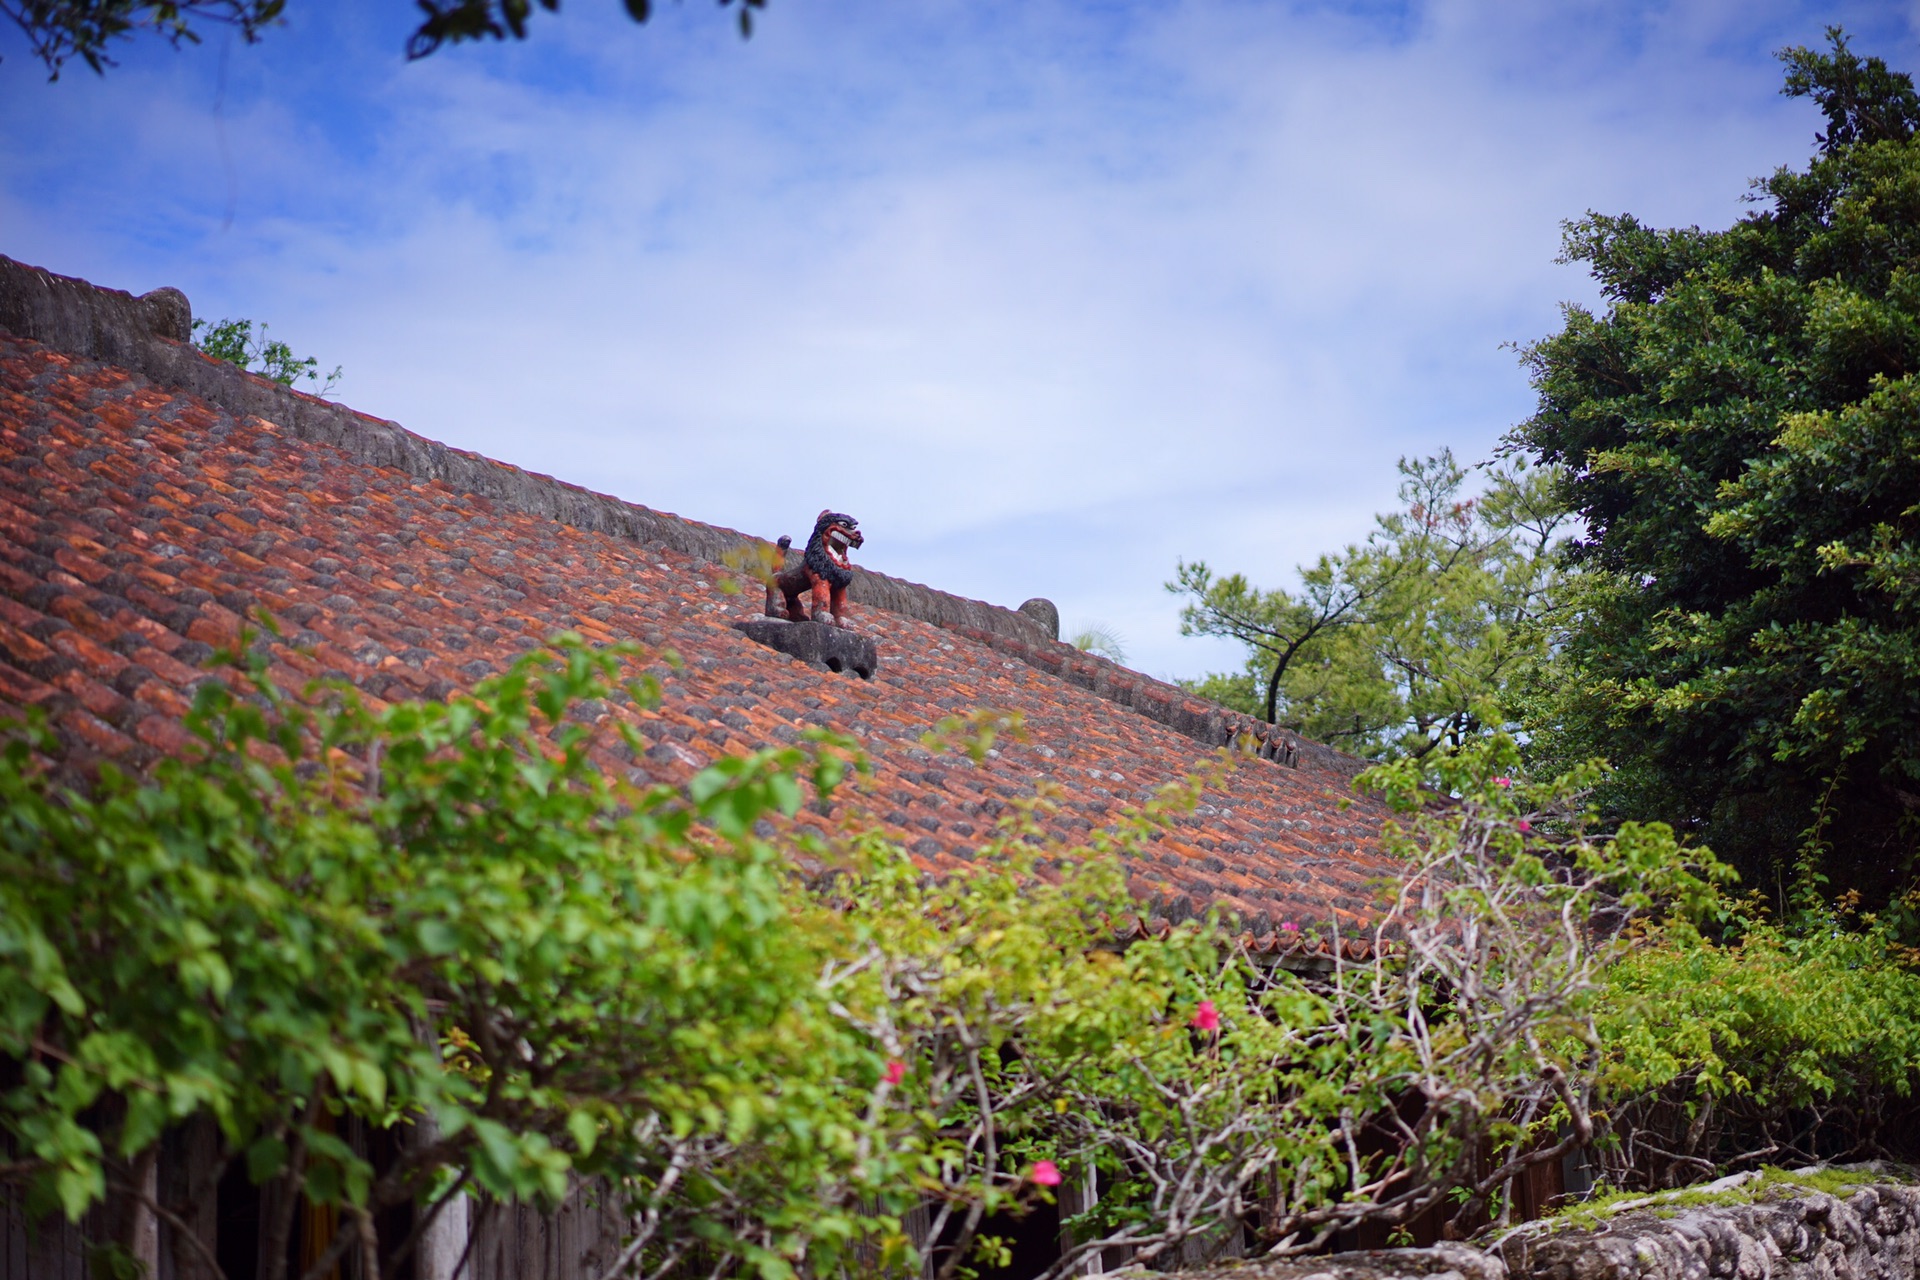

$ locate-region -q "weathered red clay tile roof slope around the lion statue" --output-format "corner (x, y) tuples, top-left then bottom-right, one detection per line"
(0, 287), (1392, 959)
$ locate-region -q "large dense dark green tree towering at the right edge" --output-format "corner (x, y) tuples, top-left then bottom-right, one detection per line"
(1513, 29), (1920, 900)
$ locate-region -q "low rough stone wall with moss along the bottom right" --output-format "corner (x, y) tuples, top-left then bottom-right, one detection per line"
(1159, 1180), (1920, 1280)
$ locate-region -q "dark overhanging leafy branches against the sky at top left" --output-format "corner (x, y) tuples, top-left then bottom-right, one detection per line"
(0, 0), (766, 81)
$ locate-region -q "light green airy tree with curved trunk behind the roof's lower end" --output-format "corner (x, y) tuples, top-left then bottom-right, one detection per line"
(1169, 453), (1569, 758)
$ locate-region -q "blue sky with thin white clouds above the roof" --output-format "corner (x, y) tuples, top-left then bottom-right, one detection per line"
(0, 0), (1920, 676)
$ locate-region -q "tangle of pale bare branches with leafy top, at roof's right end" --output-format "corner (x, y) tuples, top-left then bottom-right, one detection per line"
(1354, 735), (1730, 1228)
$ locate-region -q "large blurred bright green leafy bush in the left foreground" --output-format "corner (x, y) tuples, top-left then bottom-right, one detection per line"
(0, 643), (868, 1280)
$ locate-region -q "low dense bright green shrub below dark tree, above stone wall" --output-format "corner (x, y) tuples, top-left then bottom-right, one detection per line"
(1599, 915), (1920, 1190)
